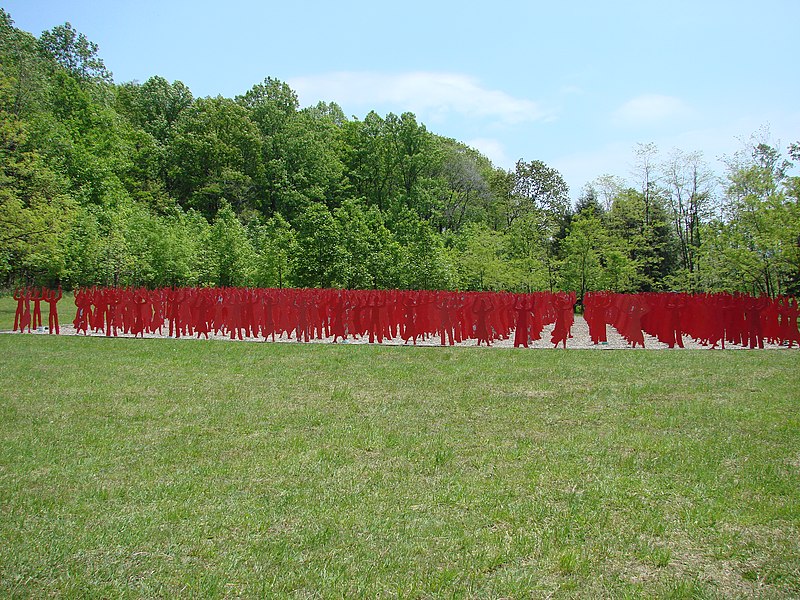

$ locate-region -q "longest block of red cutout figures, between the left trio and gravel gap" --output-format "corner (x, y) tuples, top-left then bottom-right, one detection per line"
(74, 288), (575, 347)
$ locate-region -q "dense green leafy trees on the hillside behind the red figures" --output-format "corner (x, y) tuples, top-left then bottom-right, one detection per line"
(0, 9), (800, 297)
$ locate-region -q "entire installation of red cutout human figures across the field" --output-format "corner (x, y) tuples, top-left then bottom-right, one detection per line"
(7, 287), (800, 348)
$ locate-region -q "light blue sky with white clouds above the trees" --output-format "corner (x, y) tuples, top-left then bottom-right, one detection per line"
(0, 0), (800, 197)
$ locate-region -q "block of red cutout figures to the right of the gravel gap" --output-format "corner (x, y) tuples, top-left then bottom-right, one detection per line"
(584, 292), (800, 348)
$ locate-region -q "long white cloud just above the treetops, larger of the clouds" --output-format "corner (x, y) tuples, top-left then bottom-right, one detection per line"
(287, 71), (547, 124)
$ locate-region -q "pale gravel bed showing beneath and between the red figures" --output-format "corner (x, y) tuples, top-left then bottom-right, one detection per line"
(6, 315), (798, 350)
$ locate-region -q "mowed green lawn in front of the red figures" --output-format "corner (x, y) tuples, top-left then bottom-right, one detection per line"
(0, 312), (800, 598)
